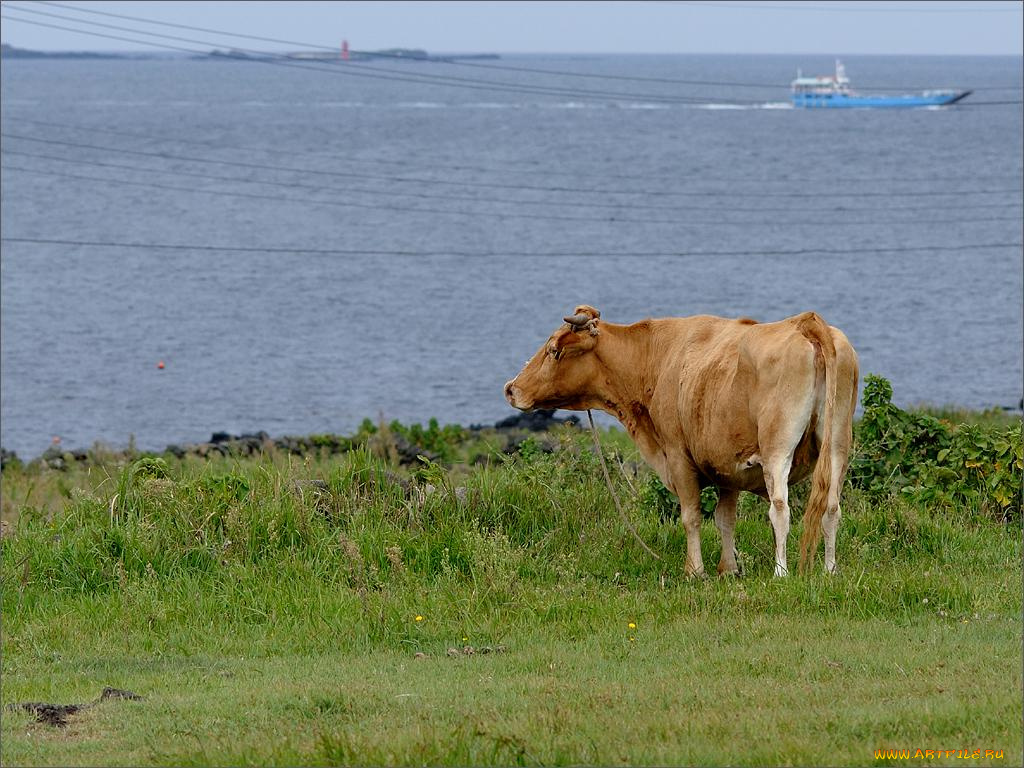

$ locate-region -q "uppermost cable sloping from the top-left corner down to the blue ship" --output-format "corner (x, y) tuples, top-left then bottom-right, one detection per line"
(25, 0), (1021, 91)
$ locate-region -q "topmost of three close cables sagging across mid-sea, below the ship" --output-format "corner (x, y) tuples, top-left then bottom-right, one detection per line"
(6, 131), (1021, 199)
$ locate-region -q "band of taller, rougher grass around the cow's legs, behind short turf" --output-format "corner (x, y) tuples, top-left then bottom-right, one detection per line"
(2, 434), (1020, 630)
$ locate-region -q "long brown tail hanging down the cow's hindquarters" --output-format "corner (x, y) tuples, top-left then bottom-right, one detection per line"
(798, 312), (840, 573)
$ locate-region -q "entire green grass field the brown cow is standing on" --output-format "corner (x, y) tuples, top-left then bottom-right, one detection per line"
(0, 417), (1024, 765)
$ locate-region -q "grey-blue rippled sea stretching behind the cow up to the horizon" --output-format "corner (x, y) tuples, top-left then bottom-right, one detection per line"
(0, 55), (1024, 457)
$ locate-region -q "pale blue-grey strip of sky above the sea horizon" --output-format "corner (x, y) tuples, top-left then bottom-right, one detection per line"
(0, 0), (1024, 55)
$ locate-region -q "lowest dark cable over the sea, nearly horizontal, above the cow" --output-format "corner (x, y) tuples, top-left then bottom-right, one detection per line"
(6, 237), (1024, 258)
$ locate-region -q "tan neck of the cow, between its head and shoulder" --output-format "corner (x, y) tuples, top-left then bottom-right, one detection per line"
(593, 321), (660, 454)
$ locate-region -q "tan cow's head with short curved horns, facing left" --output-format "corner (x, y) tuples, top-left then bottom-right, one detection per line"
(505, 304), (601, 411)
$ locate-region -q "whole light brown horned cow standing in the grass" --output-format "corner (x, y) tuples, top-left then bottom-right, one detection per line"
(505, 305), (858, 575)
